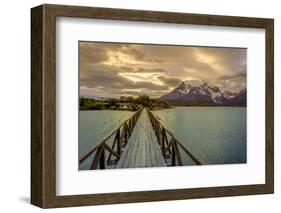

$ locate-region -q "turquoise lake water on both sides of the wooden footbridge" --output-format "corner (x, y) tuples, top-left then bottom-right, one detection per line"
(79, 107), (247, 169)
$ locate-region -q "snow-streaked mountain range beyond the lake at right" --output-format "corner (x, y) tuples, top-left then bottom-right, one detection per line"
(159, 82), (247, 106)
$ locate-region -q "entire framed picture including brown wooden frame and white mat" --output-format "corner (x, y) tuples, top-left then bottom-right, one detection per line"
(30, 4), (275, 208)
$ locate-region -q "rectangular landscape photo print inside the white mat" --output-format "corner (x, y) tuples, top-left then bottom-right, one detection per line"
(78, 41), (247, 170)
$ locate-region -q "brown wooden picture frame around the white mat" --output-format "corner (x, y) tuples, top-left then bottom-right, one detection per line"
(31, 4), (274, 208)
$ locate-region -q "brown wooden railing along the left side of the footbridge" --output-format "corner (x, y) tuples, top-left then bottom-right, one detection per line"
(79, 108), (143, 169)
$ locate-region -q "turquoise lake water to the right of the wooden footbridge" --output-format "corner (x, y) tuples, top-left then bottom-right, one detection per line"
(153, 107), (247, 164)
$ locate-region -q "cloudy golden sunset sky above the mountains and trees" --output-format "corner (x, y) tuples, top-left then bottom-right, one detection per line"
(79, 42), (247, 97)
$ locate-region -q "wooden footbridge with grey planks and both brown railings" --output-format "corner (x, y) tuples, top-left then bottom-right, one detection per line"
(79, 108), (203, 169)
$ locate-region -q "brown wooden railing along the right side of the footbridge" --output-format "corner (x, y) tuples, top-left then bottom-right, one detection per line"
(147, 109), (203, 166)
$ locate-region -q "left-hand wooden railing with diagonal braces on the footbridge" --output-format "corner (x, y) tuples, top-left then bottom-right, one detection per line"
(79, 108), (143, 170)
